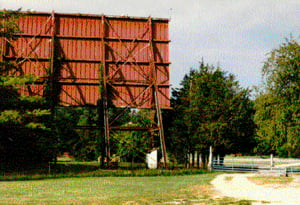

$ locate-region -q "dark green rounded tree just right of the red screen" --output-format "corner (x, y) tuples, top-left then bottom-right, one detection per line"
(168, 63), (254, 167)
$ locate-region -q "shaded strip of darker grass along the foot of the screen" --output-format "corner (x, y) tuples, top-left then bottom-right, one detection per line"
(0, 162), (207, 181)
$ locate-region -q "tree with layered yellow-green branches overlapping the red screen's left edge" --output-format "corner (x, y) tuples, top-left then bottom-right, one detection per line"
(0, 10), (55, 167)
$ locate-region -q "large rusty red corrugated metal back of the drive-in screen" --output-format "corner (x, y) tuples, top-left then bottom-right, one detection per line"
(1, 13), (170, 108)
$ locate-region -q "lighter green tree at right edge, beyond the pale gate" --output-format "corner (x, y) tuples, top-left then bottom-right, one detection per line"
(255, 38), (300, 157)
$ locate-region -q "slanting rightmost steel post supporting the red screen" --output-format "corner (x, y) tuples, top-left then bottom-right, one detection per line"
(149, 17), (167, 168)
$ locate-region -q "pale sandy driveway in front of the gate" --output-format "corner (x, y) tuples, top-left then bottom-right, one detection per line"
(211, 174), (300, 205)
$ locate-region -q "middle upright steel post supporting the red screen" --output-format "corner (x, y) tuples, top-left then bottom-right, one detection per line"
(101, 14), (110, 166)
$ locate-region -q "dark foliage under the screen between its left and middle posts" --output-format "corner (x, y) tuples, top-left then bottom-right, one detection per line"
(53, 106), (103, 161)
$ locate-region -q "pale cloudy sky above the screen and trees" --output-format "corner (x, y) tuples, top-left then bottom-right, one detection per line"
(0, 0), (300, 88)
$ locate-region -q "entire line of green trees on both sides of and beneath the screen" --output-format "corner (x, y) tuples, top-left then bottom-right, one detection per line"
(0, 11), (300, 169)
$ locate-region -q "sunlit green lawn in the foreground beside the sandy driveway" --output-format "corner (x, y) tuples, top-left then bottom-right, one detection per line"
(0, 173), (250, 204)
